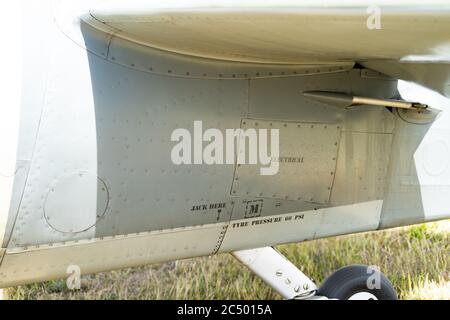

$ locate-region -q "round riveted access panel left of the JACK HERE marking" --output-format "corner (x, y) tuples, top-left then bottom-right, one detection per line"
(44, 172), (109, 233)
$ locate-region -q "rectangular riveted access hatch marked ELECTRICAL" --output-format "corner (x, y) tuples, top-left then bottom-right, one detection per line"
(232, 119), (341, 204)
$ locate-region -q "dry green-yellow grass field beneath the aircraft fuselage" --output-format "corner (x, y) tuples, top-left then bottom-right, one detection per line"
(6, 220), (450, 299)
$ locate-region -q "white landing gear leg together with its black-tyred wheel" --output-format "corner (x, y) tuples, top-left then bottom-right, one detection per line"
(232, 247), (397, 300)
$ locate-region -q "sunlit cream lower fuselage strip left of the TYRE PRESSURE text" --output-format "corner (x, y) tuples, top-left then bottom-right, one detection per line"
(0, 224), (227, 288)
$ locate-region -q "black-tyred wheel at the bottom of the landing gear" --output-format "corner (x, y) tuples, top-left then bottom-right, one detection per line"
(317, 265), (397, 300)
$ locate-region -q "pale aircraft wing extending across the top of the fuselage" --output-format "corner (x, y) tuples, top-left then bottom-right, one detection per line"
(82, 0), (450, 96)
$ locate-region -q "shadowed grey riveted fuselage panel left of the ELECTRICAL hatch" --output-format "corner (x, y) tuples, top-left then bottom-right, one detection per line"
(91, 57), (248, 235)
